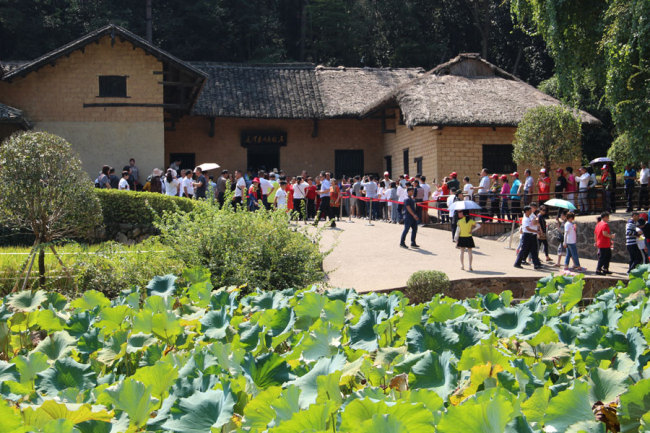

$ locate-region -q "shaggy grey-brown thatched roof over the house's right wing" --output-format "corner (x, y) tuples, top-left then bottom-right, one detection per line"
(363, 54), (600, 127)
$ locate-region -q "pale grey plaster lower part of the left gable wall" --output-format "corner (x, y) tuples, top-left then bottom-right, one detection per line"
(34, 122), (165, 183)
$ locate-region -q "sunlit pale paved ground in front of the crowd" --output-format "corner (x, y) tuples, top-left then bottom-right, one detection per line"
(321, 218), (627, 292)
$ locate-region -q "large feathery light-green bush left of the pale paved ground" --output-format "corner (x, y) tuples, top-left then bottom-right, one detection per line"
(157, 202), (324, 289)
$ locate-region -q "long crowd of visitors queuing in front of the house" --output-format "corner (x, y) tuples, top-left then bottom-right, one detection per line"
(95, 159), (650, 275)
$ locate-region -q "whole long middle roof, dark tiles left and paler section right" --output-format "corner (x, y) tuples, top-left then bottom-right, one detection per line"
(192, 62), (424, 119)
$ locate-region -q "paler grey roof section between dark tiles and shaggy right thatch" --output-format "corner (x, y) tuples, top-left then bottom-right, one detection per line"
(316, 66), (424, 117)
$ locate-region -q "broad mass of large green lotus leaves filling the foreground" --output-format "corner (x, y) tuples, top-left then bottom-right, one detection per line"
(0, 267), (650, 433)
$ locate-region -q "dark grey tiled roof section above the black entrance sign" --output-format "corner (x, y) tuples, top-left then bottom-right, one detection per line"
(192, 62), (323, 119)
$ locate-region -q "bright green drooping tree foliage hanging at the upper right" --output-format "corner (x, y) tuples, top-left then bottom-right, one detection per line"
(511, 0), (650, 163)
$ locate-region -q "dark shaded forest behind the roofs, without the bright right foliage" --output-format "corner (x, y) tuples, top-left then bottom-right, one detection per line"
(0, 0), (553, 84)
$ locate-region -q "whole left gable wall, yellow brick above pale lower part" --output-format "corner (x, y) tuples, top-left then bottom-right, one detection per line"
(0, 36), (164, 180)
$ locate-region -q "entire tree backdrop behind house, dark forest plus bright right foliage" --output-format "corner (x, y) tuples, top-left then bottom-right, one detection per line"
(0, 0), (650, 162)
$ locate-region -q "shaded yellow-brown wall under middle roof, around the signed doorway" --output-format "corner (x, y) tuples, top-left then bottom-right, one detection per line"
(165, 116), (383, 176)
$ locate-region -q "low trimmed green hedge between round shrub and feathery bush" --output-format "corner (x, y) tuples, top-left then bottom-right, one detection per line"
(95, 189), (197, 228)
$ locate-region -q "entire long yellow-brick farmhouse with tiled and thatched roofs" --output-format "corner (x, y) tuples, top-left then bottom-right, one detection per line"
(0, 25), (599, 184)
